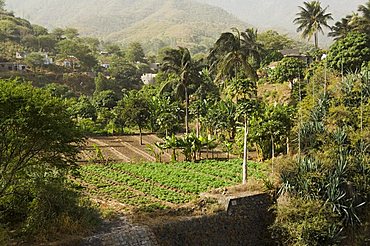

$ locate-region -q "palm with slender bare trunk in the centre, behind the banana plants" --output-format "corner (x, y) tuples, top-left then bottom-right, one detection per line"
(161, 47), (201, 134)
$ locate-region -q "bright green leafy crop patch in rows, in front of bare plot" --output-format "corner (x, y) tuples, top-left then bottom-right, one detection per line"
(80, 160), (264, 208)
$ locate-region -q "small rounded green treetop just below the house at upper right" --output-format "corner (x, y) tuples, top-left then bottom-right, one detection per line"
(272, 57), (306, 83)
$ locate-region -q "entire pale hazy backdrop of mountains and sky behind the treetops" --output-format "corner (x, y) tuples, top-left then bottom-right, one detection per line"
(6, 0), (366, 49)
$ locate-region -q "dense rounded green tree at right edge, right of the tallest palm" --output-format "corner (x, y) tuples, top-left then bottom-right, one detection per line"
(327, 32), (370, 73)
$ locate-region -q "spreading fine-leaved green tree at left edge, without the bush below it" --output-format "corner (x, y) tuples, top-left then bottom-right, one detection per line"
(0, 81), (80, 200)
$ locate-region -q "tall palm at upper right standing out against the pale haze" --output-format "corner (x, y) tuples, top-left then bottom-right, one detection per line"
(293, 1), (333, 48)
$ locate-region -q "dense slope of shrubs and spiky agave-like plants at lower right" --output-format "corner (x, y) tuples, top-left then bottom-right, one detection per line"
(275, 68), (370, 245)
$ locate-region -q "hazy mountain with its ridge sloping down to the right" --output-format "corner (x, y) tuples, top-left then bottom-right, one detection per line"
(7, 0), (246, 51)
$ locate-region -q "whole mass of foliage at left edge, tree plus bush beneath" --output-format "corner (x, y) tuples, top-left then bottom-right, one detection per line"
(0, 80), (98, 239)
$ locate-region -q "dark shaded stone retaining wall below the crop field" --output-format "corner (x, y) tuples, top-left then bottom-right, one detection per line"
(151, 194), (274, 246)
